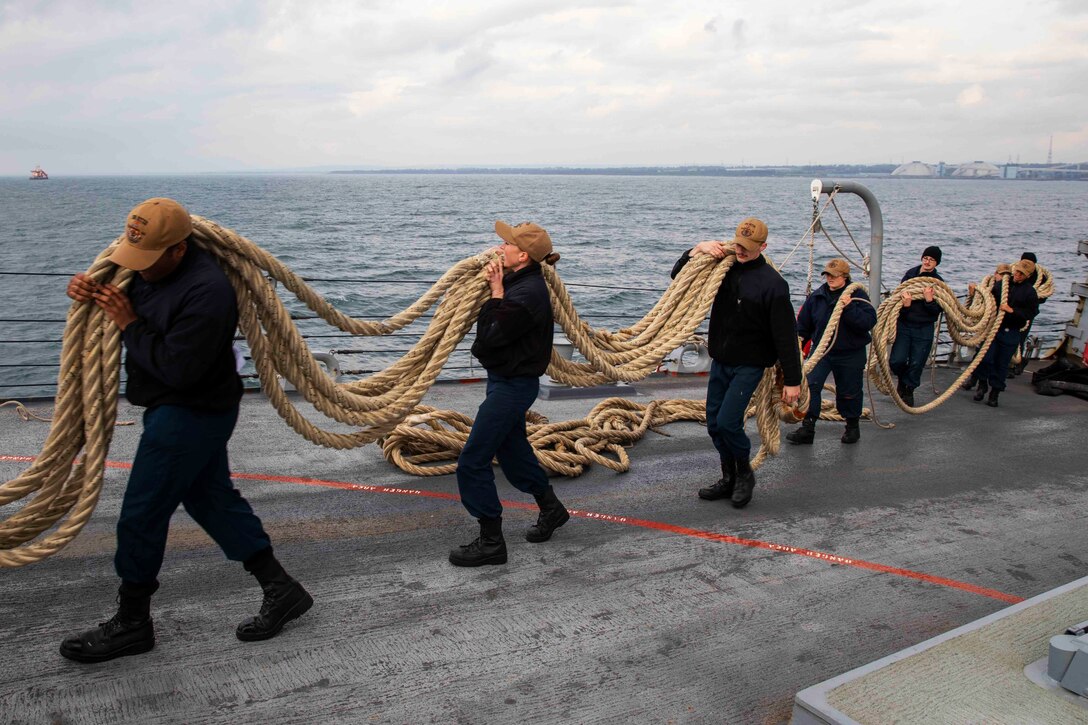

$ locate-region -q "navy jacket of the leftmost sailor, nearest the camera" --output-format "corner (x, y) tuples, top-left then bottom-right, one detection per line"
(121, 244), (242, 410)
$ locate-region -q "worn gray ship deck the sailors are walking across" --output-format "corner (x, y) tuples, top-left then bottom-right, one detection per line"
(0, 371), (1088, 723)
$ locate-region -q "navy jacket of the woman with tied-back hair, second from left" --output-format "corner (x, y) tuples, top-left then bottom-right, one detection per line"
(472, 262), (555, 378)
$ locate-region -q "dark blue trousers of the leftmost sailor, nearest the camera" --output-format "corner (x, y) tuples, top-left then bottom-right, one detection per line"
(113, 405), (272, 583)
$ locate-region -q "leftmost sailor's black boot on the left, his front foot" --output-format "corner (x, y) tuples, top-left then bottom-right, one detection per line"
(61, 581), (159, 662)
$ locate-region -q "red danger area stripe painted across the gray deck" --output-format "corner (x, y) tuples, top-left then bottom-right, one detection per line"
(0, 455), (1024, 604)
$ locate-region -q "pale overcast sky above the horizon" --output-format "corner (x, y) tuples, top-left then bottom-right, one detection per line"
(0, 0), (1088, 175)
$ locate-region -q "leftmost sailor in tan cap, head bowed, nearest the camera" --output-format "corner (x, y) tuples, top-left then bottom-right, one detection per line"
(60, 193), (313, 662)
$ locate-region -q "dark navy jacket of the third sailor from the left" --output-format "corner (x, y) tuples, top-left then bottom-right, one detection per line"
(672, 249), (801, 385)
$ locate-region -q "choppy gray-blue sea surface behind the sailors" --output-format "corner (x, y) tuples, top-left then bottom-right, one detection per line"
(0, 174), (1088, 400)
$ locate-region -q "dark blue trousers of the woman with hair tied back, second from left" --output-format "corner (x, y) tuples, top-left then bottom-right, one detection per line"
(457, 372), (548, 518)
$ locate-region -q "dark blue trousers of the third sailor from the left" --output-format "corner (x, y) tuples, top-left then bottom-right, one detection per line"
(706, 360), (764, 460)
